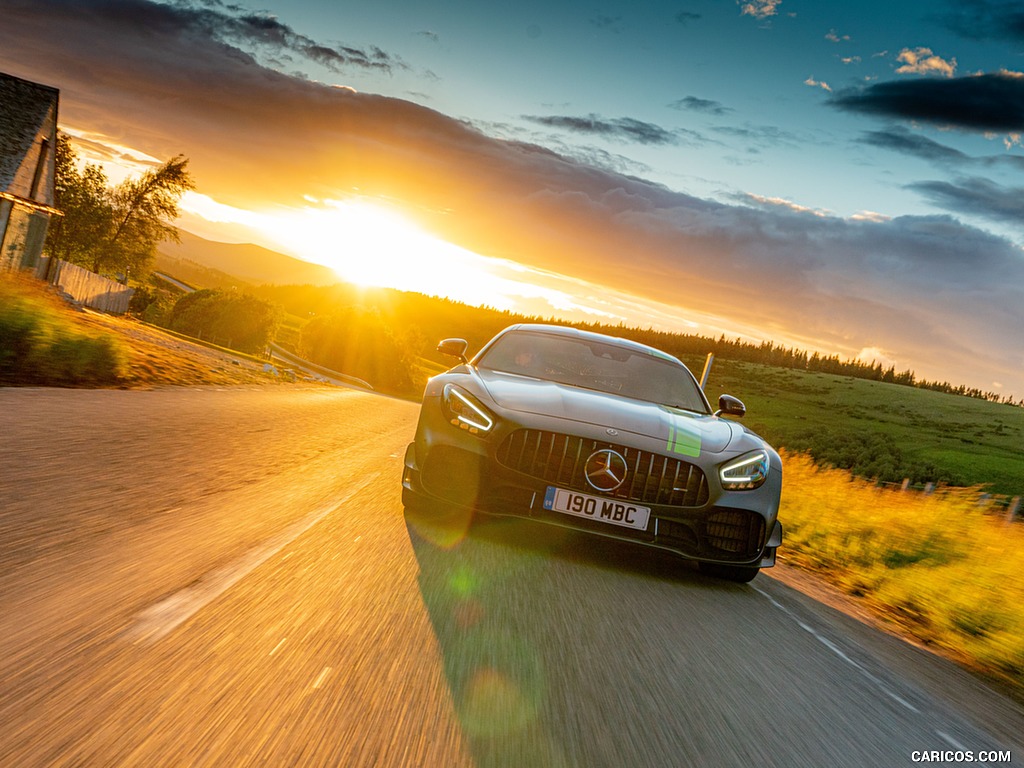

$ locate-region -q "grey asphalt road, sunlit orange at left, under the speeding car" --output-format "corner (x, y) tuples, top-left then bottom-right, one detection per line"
(0, 387), (1024, 768)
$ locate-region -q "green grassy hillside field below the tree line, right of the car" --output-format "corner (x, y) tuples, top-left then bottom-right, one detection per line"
(704, 360), (1024, 497)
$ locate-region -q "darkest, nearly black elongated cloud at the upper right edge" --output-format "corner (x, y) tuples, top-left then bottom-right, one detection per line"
(829, 73), (1024, 132)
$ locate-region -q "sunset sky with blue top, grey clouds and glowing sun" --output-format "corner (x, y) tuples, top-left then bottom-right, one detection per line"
(0, 0), (1024, 398)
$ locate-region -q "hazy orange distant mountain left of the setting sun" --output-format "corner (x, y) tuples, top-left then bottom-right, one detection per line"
(157, 229), (341, 286)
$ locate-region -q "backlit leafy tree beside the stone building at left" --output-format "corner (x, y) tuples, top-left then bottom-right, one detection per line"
(46, 133), (196, 280)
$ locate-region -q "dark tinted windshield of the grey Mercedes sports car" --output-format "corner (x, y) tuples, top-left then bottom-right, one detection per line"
(476, 332), (710, 414)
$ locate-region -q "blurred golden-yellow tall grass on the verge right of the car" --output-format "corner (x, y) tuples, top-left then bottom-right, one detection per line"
(781, 454), (1024, 696)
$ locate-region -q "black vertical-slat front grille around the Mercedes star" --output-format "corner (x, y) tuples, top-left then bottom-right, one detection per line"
(498, 429), (708, 507)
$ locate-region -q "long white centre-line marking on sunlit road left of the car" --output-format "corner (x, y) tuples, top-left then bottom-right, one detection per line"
(125, 472), (380, 643)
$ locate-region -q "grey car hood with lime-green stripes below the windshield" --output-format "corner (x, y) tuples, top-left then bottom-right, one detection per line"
(476, 370), (743, 456)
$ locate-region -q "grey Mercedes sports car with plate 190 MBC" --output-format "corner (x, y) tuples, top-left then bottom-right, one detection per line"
(402, 325), (782, 582)
